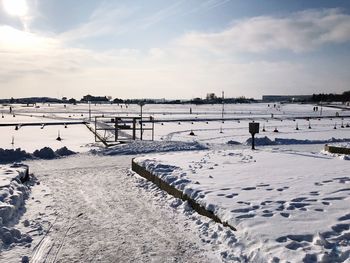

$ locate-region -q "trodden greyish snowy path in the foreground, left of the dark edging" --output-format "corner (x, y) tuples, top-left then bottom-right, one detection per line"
(24, 155), (216, 262)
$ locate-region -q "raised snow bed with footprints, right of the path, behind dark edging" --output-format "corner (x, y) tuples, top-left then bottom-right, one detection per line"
(135, 149), (350, 262)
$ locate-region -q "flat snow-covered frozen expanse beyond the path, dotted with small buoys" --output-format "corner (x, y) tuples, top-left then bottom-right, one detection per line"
(0, 103), (350, 152)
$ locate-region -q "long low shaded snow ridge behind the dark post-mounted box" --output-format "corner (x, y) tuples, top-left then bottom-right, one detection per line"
(245, 136), (350, 146)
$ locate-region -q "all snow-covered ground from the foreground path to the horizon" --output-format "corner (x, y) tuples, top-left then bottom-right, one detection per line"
(0, 103), (350, 262)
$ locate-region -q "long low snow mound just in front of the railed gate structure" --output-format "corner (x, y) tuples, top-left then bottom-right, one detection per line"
(99, 141), (207, 155)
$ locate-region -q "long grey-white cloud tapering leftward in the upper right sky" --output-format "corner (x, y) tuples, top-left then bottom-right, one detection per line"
(178, 9), (350, 53)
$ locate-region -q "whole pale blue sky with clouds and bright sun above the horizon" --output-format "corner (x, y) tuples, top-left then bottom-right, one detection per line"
(0, 0), (350, 99)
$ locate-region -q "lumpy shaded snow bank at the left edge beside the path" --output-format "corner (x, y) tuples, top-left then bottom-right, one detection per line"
(0, 164), (32, 251)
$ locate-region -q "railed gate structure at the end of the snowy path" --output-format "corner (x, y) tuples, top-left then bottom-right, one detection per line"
(94, 116), (154, 144)
